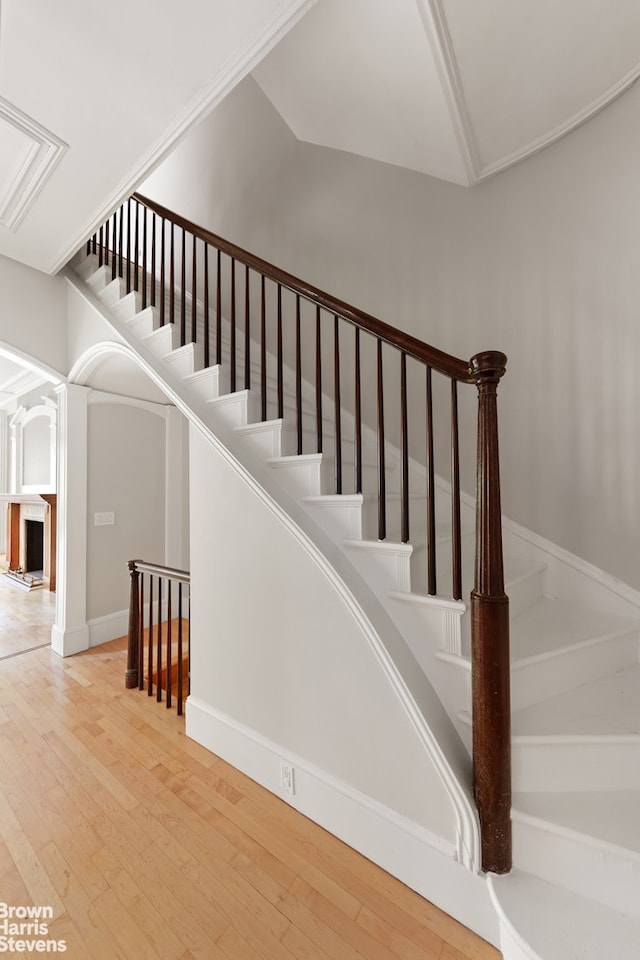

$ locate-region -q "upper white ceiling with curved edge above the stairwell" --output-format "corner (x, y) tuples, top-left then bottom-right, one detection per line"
(253, 0), (640, 186)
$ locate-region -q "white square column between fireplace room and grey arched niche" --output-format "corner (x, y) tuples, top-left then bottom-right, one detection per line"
(51, 383), (90, 657)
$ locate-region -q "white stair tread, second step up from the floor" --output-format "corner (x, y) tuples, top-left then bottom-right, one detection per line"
(513, 790), (640, 860)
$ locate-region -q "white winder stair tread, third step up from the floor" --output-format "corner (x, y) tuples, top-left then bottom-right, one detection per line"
(512, 664), (640, 742)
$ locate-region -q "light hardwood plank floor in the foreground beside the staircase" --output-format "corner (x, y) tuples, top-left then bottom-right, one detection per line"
(0, 600), (500, 960)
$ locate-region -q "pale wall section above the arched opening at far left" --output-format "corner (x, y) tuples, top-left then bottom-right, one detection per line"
(0, 256), (68, 374)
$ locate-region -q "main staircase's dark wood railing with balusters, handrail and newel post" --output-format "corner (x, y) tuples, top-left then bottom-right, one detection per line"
(87, 195), (511, 873)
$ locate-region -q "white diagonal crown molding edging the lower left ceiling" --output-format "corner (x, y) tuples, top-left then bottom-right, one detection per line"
(47, 0), (318, 274)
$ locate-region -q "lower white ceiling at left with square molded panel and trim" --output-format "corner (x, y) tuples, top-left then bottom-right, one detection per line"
(0, 0), (314, 273)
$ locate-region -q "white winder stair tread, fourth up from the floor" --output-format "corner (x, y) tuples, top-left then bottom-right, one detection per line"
(511, 598), (640, 662)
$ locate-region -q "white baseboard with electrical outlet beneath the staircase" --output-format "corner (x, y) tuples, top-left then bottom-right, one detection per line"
(186, 696), (499, 944)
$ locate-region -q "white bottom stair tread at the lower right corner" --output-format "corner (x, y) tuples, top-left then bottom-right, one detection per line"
(490, 870), (640, 960)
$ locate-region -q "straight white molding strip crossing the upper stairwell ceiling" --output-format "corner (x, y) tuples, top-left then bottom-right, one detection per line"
(416, 0), (481, 186)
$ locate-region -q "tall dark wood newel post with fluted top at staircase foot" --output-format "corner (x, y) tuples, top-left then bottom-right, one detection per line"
(470, 351), (511, 873)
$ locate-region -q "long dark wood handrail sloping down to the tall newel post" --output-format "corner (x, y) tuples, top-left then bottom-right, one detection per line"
(134, 193), (476, 383)
